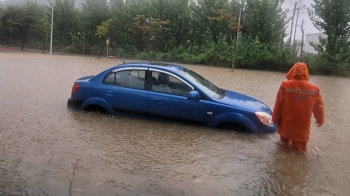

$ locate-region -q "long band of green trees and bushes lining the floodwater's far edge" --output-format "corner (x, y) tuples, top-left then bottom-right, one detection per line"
(0, 0), (350, 76)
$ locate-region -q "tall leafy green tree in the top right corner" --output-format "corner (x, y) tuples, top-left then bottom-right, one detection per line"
(308, 0), (350, 74)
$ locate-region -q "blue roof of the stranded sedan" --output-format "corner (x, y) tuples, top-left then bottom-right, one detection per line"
(114, 62), (185, 71)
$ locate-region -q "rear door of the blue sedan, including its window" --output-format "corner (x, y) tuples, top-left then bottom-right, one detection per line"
(102, 68), (147, 115)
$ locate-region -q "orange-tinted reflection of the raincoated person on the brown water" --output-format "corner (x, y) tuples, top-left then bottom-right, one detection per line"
(235, 147), (325, 195)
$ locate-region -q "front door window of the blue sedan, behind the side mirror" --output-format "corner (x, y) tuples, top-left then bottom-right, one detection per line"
(152, 71), (192, 97)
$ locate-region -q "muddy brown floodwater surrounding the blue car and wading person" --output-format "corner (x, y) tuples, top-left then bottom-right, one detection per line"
(0, 51), (350, 196)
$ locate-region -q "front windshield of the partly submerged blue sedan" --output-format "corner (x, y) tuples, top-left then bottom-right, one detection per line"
(183, 69), (225, 99)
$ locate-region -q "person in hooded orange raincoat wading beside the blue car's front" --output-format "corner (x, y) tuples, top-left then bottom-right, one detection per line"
(272, 62), (325, 151)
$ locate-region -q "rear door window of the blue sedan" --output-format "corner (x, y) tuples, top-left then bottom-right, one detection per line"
(115, 70), (146, 89)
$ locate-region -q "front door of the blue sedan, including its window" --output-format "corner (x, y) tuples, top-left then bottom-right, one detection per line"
(148, 69), (204, 122)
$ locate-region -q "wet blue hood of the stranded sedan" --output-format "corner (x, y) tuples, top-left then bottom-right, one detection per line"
(217, 90), (272, 114)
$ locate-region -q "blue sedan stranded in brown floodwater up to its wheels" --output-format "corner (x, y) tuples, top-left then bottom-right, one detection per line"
(67, 62), (276, 133)
